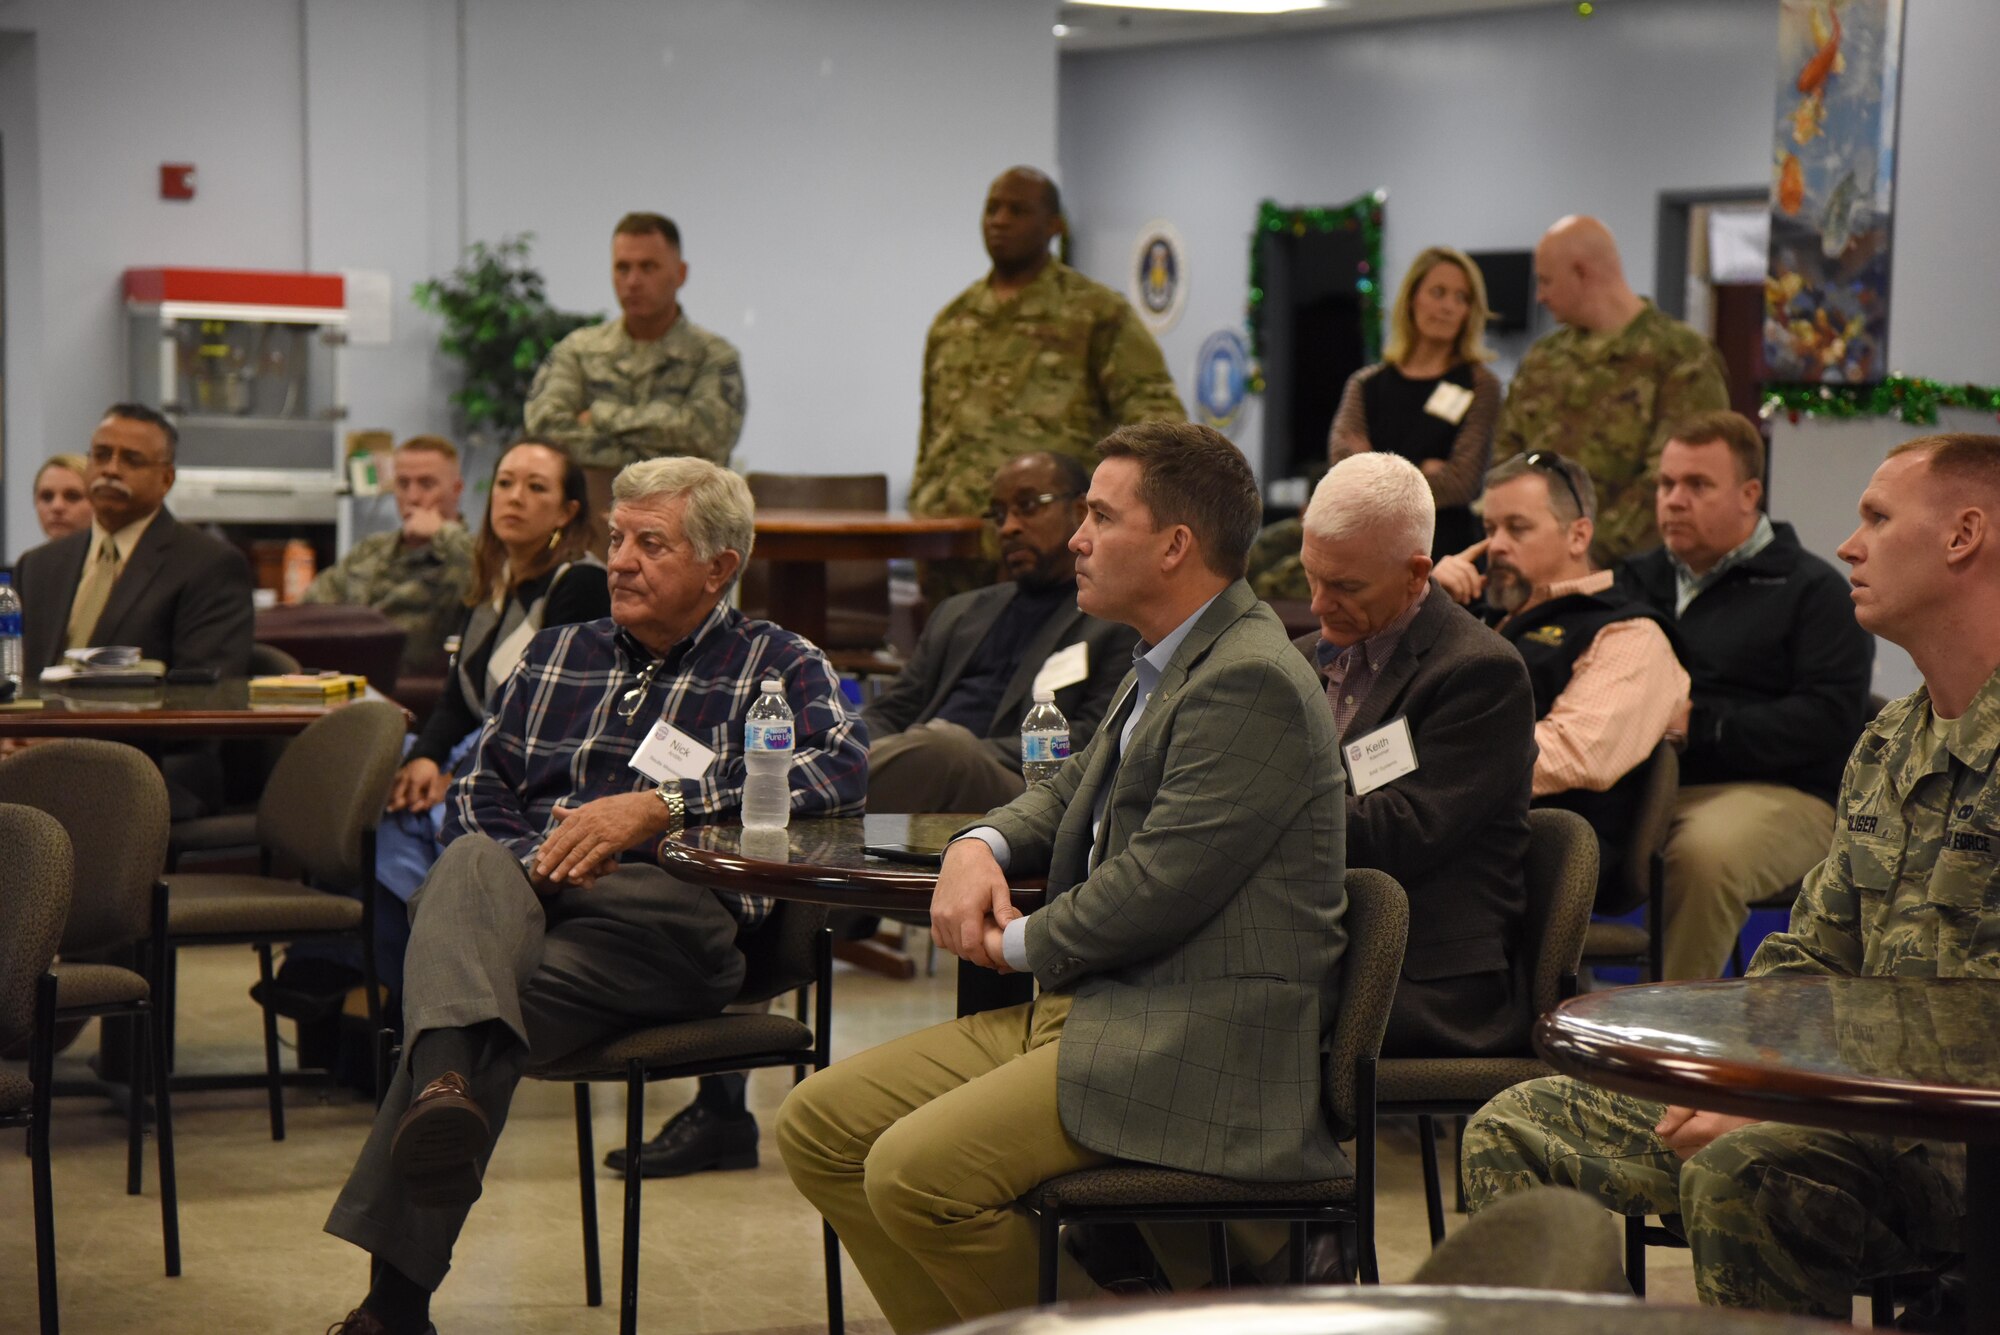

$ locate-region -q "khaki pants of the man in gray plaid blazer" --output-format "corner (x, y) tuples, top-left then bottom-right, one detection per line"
(778, 995), (1110, 1335)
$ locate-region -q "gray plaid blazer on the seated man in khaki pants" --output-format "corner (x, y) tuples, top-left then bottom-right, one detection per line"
(980, 580), (1346, 1181)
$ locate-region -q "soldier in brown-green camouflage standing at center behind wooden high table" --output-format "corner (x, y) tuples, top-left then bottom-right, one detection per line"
(910, 168), (1188, 602)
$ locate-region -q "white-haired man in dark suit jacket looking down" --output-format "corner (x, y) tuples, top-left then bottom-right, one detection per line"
(1296, 452), (1536, 1057)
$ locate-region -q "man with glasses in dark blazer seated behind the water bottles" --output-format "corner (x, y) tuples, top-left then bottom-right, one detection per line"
(862, 454), (1138, 811)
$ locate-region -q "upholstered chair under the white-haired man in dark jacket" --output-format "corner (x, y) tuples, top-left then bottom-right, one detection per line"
(1356, 809), (1598, 1245)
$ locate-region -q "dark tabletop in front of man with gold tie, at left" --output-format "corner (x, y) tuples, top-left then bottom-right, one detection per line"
(0, 677), (406, 741)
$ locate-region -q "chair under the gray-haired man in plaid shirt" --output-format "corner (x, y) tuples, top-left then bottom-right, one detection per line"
(528, 901), (842, 1335)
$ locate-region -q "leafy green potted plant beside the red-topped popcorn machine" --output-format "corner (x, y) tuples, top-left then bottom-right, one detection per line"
(412, 232), (604, 442)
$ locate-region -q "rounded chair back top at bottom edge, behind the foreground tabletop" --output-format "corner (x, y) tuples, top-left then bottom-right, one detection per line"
(1410, 1187), (1632, 1297)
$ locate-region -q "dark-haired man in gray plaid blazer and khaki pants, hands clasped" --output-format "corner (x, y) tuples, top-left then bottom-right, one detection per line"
(778, 422), (1346, 1335)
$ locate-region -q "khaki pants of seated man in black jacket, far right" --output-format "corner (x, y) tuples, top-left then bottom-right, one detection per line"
(1664, 783), (1834, 979)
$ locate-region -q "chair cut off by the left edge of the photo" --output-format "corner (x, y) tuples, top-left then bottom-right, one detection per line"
(0, 803), (72, 1335)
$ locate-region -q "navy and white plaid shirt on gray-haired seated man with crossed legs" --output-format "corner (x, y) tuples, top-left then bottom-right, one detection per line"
(444, 604), (868, 927)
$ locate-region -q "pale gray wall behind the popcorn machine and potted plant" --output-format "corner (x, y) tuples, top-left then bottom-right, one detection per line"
(0, 0), (1056, 554)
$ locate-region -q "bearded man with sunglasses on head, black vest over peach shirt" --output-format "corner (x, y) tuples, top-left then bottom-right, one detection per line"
(1434, 450), (1688, 903)
